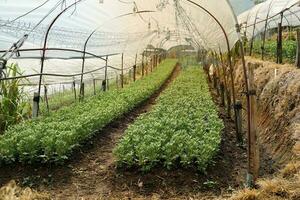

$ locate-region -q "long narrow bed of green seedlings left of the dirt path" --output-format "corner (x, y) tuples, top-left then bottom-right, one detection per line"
(0, 60), (176, 163)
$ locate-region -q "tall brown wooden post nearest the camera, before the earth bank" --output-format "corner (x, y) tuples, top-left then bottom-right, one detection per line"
(247, 65), (259, 187)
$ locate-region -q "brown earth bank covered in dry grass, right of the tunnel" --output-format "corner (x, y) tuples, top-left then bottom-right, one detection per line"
(235, 57), (300, 166)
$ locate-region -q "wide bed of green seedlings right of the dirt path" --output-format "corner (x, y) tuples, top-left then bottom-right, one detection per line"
(114, 67), (224, 171)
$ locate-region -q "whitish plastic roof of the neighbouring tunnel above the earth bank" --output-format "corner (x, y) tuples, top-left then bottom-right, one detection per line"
(238, 0), (300, 39)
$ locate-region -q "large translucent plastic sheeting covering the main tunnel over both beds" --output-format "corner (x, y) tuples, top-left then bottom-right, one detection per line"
(0, 0), (239, 85)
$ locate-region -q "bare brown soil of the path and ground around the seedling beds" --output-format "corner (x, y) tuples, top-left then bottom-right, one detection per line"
(0, 66), (251, 200)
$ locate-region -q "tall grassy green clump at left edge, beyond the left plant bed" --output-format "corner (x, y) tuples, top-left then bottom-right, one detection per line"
(0, 64), (31, 135)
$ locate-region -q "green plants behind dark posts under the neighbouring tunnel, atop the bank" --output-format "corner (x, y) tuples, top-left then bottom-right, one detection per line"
(253, 40), (297, 63)
